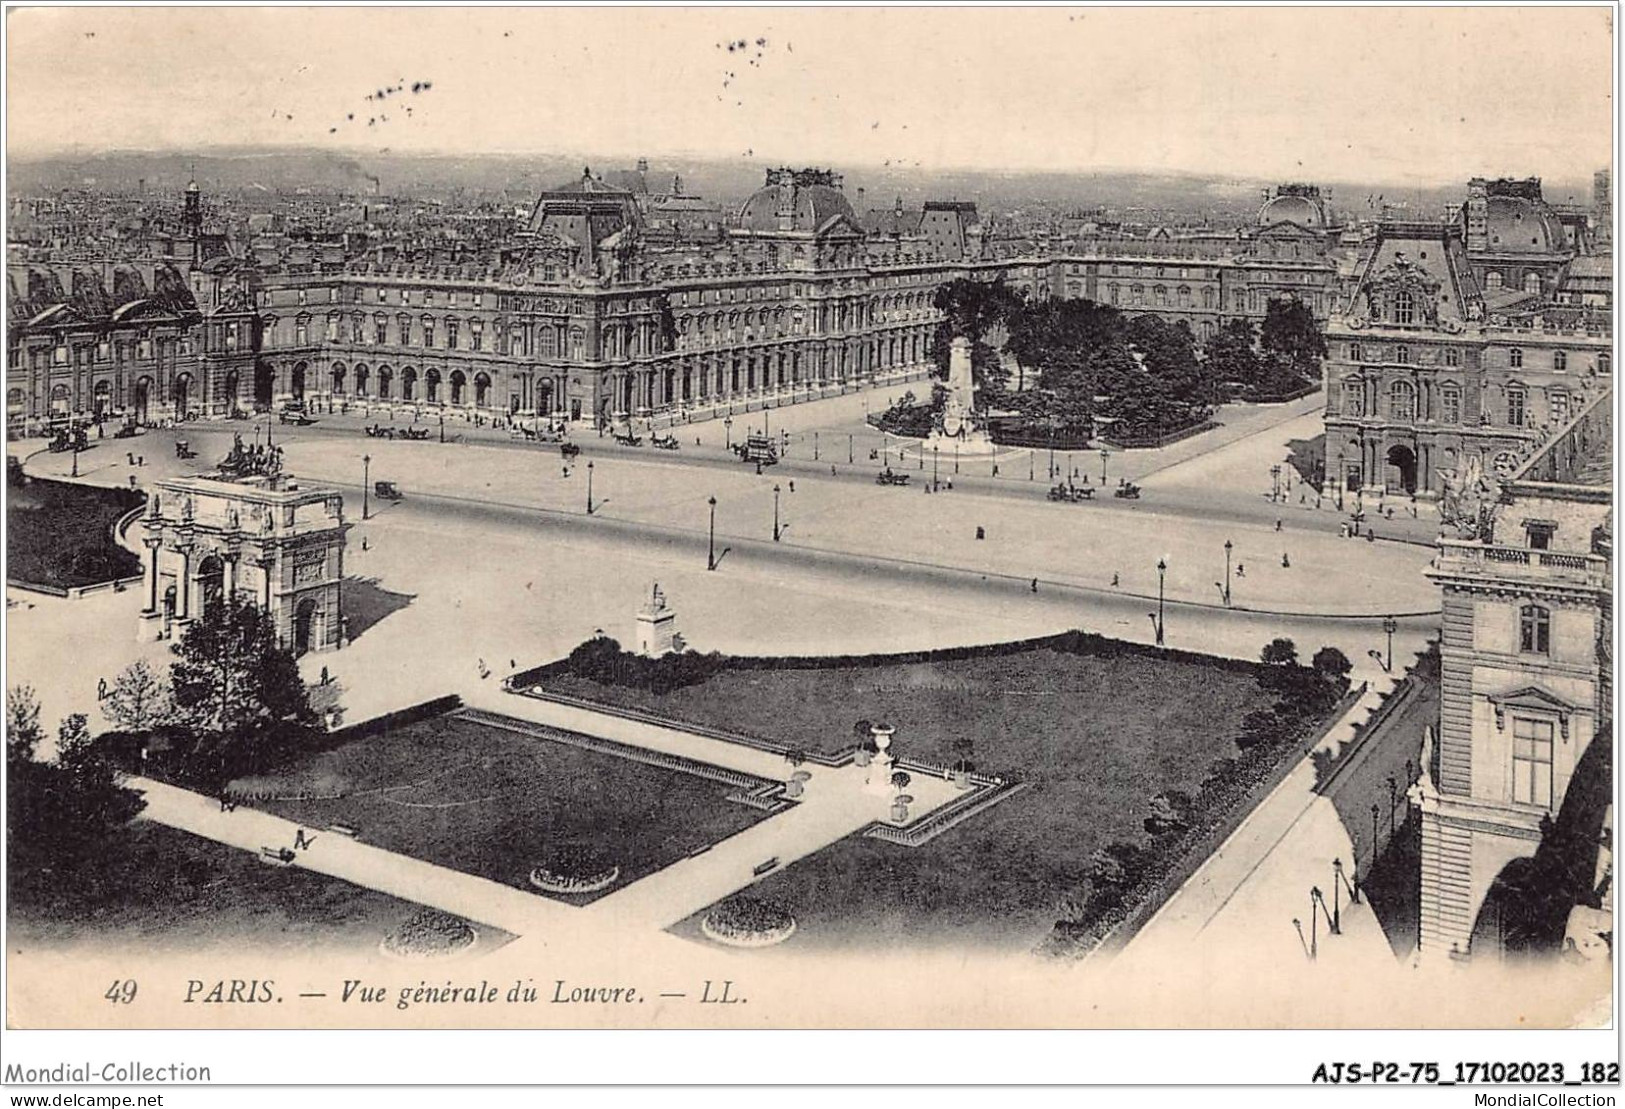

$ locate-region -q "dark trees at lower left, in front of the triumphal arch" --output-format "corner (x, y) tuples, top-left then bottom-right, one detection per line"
(7, 600), (319, 886)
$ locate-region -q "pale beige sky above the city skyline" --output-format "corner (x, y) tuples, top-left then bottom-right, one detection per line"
(7, 7), (1614, 184)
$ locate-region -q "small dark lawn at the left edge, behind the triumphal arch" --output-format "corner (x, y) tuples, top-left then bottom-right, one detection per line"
(5, 478), (146, 589)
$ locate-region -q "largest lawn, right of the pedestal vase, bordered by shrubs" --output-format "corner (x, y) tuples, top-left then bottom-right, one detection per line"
(541, 647), (1306, 950)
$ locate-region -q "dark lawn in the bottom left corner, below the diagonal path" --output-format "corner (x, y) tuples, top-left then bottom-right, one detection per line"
(8, 820), (464, 955)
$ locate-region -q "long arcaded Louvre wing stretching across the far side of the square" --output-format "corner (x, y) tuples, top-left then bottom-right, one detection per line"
(7, 164), (1610, 445)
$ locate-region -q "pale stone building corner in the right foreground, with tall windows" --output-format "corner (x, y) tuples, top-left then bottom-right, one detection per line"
(1415, 390), (1612, 959)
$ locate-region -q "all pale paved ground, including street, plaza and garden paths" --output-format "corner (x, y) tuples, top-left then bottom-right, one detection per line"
(8, 387), (1437, 963)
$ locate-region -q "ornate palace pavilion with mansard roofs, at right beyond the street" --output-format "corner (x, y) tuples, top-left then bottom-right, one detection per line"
(1324, 179), (1614, 496)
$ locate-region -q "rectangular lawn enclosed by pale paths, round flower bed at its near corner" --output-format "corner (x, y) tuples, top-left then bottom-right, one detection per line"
(245, 715), (762, 902)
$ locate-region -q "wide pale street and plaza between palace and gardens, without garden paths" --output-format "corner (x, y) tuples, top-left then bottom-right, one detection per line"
(8, 380), (1438, 724)
